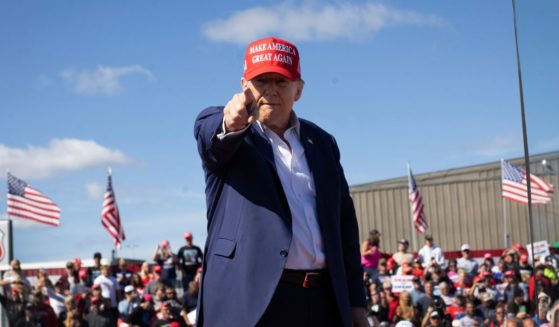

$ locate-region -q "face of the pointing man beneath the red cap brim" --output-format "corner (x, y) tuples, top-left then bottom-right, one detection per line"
(241, 73), (304, 130)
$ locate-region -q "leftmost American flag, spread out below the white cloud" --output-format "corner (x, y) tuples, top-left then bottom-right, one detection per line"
(7, 173), (60, 226)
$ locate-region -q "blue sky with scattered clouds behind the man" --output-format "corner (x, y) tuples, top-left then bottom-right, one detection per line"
(0, 0), (559, 262)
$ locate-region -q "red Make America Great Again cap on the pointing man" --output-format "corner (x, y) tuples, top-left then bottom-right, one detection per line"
(243, 37), (301, 81)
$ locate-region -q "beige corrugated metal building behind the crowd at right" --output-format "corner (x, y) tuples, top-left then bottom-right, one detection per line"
(350, 152), (559, 252)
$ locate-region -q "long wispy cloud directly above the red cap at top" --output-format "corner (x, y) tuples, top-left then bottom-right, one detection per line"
(202, 2), (446, 44)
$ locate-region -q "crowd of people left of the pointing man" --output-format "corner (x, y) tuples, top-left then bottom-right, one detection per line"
(0, 233), (203, 327)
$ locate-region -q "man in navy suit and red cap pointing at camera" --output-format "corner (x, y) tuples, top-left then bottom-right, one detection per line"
(194, 38), (368, 327)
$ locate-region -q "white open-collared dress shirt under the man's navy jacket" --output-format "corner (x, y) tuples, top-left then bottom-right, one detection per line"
(218, 112), (326, 270)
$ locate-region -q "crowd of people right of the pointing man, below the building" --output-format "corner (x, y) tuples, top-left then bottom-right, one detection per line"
(361, 230), (559, 327)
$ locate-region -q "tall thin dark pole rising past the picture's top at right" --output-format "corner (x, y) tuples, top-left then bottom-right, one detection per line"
(512, 0), (538, 313)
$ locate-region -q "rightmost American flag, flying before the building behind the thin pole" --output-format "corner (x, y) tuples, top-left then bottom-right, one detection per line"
(501, 160), (555, 204)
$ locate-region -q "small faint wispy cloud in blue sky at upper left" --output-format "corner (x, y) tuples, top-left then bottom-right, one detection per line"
(60, 65), (155, 95)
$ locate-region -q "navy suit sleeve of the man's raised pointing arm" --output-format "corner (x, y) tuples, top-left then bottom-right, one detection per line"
(194, 107), (252, 171)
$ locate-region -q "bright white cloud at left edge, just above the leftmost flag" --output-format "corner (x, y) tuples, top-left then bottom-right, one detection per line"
(0, 139), (131, 178)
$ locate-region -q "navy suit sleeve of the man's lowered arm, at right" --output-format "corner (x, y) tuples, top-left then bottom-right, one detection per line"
(332, 137), (367, 308)
